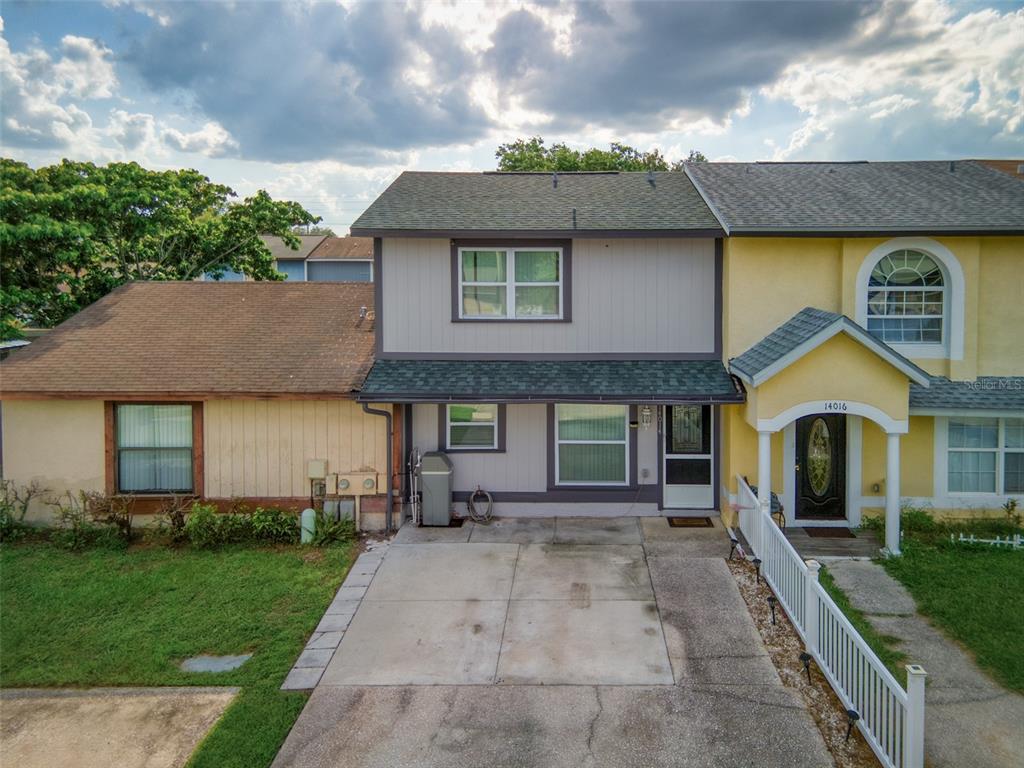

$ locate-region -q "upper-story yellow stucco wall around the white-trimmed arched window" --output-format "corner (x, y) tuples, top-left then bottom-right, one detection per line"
(723, 237), (1024, 380)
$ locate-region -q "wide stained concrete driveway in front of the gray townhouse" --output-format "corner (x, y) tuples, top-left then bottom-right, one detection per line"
(274, 518), (831, 768)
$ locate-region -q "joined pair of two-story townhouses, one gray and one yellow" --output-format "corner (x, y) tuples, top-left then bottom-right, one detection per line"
(352, 162), (1024, 549)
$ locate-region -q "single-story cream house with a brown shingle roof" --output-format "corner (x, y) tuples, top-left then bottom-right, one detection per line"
(0, 282), (397, 527)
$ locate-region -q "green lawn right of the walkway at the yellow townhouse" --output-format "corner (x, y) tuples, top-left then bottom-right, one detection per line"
(883, 534), (1024, 693)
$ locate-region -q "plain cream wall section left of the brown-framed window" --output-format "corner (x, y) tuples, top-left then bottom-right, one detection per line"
(2, 400), (105, 521)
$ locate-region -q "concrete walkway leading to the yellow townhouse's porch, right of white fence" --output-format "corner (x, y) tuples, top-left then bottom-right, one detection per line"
(827, 560), (1024, 768)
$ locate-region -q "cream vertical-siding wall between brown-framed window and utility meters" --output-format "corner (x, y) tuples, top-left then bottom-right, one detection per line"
(203, 400), (387, 499)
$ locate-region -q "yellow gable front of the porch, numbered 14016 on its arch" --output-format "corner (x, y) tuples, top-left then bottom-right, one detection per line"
(745, 334), (909, 427)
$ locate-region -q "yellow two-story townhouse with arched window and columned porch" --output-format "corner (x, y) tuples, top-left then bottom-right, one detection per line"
(687, 161), (1024, 550)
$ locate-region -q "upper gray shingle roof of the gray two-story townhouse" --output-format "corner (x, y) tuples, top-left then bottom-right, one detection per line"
(351, 171), (721, 236)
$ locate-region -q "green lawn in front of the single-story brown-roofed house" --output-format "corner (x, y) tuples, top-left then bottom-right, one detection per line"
(0, 544), (353, 768)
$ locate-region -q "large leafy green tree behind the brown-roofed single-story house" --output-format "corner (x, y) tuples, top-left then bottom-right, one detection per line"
(0, 158), (319, 339)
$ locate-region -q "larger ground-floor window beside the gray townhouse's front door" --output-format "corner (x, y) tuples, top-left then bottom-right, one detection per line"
(555, 403), (630, 485)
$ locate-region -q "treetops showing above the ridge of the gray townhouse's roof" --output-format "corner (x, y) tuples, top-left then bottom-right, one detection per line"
(495, 136), (708, 172)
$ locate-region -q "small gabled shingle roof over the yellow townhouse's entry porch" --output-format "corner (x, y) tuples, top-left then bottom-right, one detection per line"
(729, 306), (928, 384)
